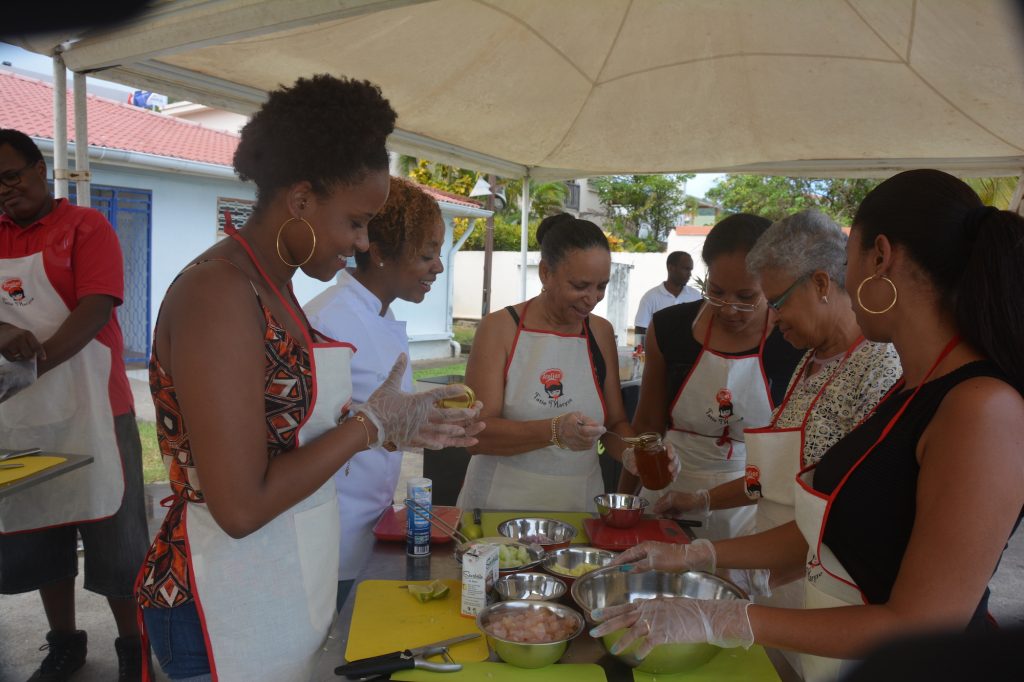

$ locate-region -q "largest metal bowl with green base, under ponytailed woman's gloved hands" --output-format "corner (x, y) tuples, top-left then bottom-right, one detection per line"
(572, 566), (746, 674)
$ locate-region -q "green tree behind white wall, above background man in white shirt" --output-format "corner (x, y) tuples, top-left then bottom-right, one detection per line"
(591, 174), (693, 243)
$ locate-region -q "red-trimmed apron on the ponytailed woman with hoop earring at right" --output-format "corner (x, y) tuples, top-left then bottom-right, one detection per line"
(794, 336), (959, 682)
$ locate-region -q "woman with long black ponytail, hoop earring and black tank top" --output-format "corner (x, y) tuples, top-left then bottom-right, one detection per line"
(599, 170), (1024, 681)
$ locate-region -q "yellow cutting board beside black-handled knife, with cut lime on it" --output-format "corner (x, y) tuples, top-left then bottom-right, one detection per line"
(345, 580), (488, 663)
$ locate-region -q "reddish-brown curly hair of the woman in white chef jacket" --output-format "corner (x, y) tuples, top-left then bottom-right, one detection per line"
(355, 175), (441, 268)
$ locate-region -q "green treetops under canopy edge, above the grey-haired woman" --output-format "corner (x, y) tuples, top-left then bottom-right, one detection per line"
(707, 175), (879, 225)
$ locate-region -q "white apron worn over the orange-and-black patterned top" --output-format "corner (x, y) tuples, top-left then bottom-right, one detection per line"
(182, 229), (355, 682)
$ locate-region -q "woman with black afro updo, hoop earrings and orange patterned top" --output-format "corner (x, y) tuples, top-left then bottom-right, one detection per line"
(137, 75), (481, 682)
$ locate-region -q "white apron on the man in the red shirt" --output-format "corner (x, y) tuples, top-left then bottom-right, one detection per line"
(0, 253), (125, 532)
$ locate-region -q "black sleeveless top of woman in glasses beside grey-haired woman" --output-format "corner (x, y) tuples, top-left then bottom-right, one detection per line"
(652, 301), (804, 408)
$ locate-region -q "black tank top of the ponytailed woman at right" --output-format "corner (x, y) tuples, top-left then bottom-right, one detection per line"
(814, 360), (1024, 631)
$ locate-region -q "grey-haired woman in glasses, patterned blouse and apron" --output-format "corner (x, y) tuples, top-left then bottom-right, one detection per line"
(638, 210), (902, 606)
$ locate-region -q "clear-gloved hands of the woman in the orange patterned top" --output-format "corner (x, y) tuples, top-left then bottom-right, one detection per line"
(357, 353), (484, 450)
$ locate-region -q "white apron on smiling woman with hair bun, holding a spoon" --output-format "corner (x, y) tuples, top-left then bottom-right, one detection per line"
(458, 303), (605, 512)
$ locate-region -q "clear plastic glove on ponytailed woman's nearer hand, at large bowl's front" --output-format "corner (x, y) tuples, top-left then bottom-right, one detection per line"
(590, 597), (754, 658)
